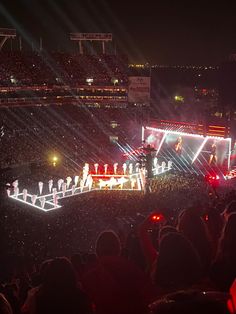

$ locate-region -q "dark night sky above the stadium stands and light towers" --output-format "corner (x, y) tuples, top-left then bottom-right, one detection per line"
(0, 0), (236, 65)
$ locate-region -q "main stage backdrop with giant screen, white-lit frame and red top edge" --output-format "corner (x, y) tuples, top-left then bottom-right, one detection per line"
(142, 123), (231, 175)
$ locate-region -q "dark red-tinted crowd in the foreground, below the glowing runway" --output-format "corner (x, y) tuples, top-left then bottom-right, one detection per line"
(0, 172), (236, 314)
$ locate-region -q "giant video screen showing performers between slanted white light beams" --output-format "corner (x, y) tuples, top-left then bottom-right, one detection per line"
(143, 127), (231, 173)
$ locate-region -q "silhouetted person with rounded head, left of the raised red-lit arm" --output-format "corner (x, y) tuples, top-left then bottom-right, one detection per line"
(82, 230), (152, 314)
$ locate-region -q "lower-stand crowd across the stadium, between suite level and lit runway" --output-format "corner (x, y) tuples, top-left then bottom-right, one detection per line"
(0, 105), (141, 169)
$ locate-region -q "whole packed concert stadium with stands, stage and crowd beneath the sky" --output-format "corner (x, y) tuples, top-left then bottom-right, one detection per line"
(0, 28), (236, 314)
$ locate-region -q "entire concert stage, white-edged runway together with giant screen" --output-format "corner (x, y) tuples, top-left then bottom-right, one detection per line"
(7, 123), (231, 212)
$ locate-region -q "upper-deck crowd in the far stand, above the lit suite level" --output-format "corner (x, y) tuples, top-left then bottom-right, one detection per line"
(0, 51), (128, 86)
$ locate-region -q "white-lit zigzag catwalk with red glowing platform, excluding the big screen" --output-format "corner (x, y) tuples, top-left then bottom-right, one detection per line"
(7, 164), (173, 212)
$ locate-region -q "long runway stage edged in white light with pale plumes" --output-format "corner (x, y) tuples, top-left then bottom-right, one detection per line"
(7, 162), (172, 212)
